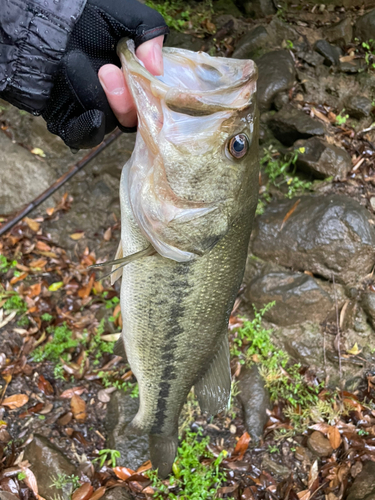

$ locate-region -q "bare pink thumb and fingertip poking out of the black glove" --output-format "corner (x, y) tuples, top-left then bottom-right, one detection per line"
(99, 36), (164, 132)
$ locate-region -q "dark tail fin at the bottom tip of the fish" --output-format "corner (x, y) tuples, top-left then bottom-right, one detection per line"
(149, 433), (178, 479)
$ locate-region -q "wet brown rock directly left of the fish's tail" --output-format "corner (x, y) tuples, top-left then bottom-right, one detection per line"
(106, 391), (149, 470)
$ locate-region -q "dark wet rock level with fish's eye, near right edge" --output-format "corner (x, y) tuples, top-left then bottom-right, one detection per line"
(294, 137), (352, 180)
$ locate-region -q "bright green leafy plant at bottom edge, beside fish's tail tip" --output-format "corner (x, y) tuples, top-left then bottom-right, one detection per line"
(147, 432), (226, 500)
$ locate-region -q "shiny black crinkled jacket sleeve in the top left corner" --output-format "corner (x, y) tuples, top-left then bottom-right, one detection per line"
(0, 0), (86, 114)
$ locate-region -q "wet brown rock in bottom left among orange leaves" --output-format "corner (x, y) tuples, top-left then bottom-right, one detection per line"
(24, 434), (76, 500)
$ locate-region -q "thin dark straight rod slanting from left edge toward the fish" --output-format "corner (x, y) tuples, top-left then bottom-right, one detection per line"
(0, 129), (121, 236)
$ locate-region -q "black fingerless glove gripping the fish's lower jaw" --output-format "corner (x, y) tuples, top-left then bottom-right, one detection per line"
(43, 0), (169, 149)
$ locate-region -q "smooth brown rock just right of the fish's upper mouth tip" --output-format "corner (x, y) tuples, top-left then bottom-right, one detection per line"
(256, 50), (295, 111)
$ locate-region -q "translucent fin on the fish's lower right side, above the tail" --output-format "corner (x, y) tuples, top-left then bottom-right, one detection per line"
(194, 332), (232, 415)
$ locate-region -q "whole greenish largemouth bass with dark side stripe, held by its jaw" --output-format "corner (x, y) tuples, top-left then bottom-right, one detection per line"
(114, 42), (259, 477)
